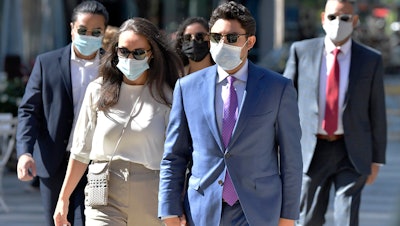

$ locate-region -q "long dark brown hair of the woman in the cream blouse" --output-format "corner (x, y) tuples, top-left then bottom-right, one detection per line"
(97, 17), (184, 110)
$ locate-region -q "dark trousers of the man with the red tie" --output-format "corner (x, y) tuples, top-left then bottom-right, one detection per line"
(296, 139), (367, 226)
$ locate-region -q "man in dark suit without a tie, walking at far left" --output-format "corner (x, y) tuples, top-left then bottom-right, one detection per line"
(17, 1), (108, 225)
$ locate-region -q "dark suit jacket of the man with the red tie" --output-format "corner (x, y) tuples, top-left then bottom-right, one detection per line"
(284, 38), (387, 175)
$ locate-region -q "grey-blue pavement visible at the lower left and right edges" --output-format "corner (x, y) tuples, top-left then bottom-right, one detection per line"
(0, 75), (400, 226)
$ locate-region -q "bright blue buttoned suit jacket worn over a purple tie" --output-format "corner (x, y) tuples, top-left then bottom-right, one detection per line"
(159, 62), (302, 226)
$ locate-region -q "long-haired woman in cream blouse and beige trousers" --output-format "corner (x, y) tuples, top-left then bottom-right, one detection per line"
(54, 18), (183, 226)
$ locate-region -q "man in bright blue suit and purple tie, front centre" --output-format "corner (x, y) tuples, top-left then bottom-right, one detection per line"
(159, 2), (302, 226)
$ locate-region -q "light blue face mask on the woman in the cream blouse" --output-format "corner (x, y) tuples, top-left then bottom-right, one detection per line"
(117, 57), (149, 81)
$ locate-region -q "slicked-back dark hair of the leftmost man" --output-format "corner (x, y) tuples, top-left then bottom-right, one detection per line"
(71, 1), (108, 27)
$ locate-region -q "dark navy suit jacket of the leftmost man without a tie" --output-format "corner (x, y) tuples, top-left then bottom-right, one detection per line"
(16, 44), (74, 177)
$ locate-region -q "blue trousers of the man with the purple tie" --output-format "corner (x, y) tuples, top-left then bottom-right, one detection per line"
(219, 202), (249, 226)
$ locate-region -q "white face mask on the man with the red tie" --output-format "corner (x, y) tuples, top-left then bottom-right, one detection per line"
(322, 18), (353, 42)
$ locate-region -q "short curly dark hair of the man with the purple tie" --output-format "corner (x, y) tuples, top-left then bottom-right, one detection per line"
(209, 1), (256, 36)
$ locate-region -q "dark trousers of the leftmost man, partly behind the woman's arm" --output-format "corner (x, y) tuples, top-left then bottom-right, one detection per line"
(39, 154), (87, 226)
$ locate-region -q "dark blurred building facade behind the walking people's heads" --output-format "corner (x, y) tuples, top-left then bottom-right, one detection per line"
(0, 0), (390, 71)
